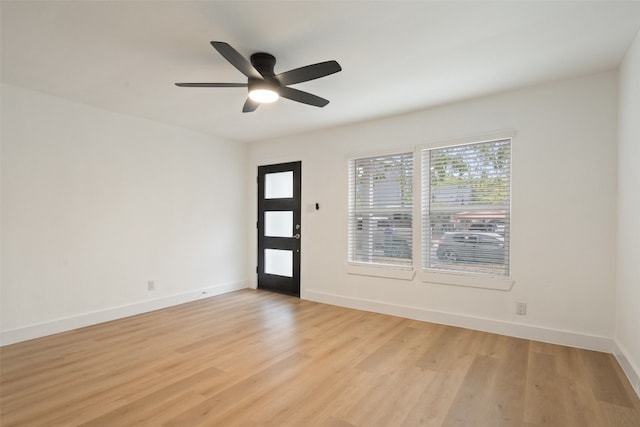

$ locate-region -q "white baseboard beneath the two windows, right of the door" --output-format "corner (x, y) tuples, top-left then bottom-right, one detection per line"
(302, 290), (613, 353)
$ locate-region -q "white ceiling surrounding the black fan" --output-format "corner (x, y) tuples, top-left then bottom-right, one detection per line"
(0, 0), (640, 142)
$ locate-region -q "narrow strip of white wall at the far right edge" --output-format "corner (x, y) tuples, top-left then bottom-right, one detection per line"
(615, 31), (640, 395)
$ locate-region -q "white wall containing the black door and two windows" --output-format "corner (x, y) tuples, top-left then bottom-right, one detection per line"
(249, 72), (620, 350)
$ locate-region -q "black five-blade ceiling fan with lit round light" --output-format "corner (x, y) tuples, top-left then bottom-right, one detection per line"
(176, 42), (342, 113)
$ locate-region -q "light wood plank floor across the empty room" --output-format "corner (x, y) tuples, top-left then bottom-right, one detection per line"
(0, 290), (640, 427)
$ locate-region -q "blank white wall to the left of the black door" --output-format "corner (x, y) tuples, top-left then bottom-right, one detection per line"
(1, 85), (248, 344)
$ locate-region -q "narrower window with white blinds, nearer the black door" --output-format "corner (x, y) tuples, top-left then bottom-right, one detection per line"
(349, 152), (413, 267)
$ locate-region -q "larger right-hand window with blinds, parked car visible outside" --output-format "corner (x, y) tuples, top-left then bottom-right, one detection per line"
(422, 139), (511, 277)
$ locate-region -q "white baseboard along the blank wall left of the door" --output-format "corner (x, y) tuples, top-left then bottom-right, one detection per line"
(0, 281), (249, 346)
